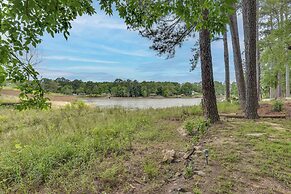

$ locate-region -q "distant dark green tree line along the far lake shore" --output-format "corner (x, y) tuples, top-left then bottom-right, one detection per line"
(41, 77), (236, 97)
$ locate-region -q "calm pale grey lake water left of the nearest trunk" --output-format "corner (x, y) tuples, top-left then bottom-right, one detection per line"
(83, 98), (201, 109)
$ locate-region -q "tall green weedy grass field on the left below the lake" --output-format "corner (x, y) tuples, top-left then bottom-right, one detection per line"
(0, 103), (199, 193)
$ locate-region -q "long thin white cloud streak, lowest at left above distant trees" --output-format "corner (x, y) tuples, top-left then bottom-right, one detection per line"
(43, 56), (119, 64)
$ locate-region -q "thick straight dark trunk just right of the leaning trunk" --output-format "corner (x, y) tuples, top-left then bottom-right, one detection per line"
(243, 0), (259, 119)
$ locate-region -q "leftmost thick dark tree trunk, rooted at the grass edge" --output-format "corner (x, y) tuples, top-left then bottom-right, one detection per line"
(199, 10), (219, 123)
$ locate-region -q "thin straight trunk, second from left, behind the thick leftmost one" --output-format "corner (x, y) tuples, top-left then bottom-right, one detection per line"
(223, 31), (230, 102)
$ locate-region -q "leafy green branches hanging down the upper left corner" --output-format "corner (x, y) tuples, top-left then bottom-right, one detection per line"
(0, 0), (95, 109)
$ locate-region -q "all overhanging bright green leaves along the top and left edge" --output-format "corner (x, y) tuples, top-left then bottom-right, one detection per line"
(0, 0), (236, 108)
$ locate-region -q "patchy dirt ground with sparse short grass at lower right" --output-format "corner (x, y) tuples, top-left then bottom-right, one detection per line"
(148, 119), (291, 194)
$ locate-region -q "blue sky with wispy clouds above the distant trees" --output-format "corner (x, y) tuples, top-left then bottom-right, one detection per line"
(37, 8), (246, 83)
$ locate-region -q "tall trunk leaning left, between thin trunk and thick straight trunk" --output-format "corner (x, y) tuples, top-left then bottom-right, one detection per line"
(230, 13), (246, 110)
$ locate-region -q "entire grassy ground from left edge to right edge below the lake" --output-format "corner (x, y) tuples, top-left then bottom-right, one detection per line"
(0, 102), (291, 193)
